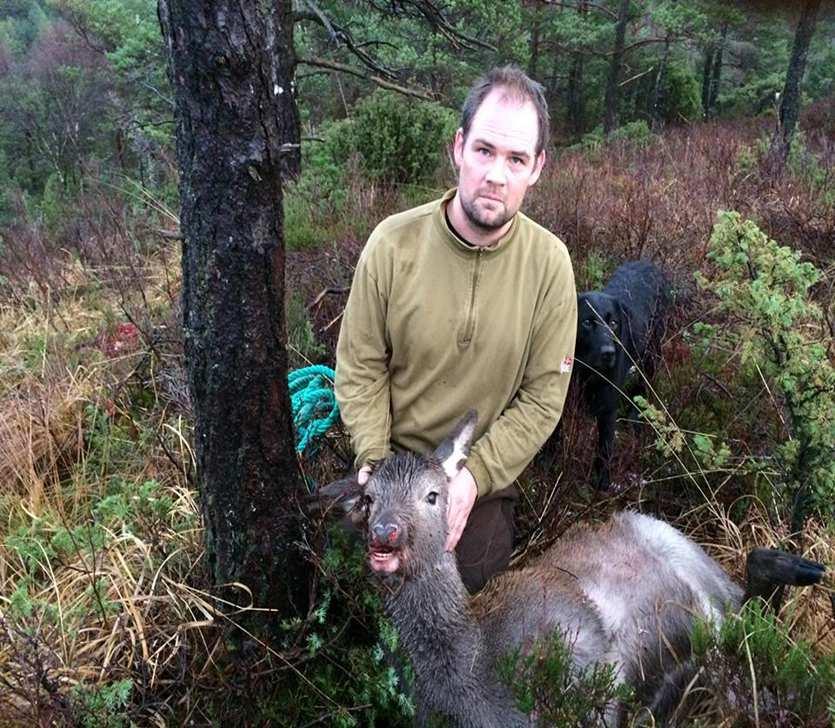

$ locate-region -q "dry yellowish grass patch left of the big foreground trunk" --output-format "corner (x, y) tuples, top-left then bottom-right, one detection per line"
(0, 230), (225, 725)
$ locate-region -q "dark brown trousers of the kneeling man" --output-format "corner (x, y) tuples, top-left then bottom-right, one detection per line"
(455, 485), (519, 594)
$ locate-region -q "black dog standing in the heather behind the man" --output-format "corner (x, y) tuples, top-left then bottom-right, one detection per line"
(574, 261), (669, 490)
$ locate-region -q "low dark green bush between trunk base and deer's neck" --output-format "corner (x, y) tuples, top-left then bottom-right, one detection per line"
(240, 525), (415, 728)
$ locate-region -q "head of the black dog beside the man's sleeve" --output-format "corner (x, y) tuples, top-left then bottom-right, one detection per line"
(575, 291), (628, 373)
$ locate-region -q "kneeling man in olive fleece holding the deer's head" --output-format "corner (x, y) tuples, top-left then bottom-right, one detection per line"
(336, 67), (577, 591)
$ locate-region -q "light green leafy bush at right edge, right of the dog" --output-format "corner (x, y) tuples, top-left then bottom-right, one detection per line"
(696, 212), (835, 531)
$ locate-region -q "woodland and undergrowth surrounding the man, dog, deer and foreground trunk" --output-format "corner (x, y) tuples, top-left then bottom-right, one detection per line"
(0, 0), (835, 726)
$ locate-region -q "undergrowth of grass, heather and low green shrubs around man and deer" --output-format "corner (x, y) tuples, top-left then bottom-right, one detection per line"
(0, 116), (835, 726)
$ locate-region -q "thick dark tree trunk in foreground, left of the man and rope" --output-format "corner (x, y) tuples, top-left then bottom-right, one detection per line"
(159, 0), (306, 624)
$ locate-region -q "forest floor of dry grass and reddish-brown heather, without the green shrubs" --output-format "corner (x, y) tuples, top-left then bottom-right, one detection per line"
(0, 111), (835, 725)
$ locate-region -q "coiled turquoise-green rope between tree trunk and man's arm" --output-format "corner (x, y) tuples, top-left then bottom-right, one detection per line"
(287, 364), (339, 453)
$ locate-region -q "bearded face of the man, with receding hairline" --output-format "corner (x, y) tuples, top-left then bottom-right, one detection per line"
(453, 88), (545, 232)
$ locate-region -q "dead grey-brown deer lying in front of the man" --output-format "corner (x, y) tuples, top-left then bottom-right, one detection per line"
(320, 412), (823, 728)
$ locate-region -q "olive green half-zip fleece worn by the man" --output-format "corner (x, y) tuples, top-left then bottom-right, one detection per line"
(335, 190), (577, 496)
